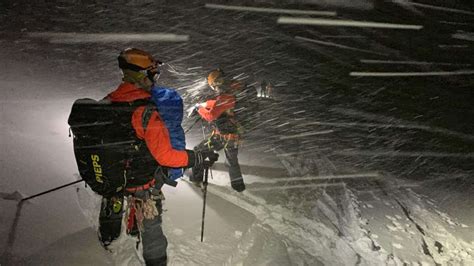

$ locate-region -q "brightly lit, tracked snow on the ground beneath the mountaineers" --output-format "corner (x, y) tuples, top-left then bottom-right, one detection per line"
(2, 151), (474, 265)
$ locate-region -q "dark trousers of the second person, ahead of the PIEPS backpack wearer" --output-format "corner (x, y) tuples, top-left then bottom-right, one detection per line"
(191, 135), (245, 192)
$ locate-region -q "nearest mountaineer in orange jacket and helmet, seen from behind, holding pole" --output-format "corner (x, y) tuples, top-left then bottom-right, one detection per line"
(99, 48), (217, 265)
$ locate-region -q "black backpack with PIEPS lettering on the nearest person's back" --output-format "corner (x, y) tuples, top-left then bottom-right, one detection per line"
(68, 99), (159, 196)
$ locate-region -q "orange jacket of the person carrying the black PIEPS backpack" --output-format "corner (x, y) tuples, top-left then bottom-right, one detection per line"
(106, 82), (189, 168)
